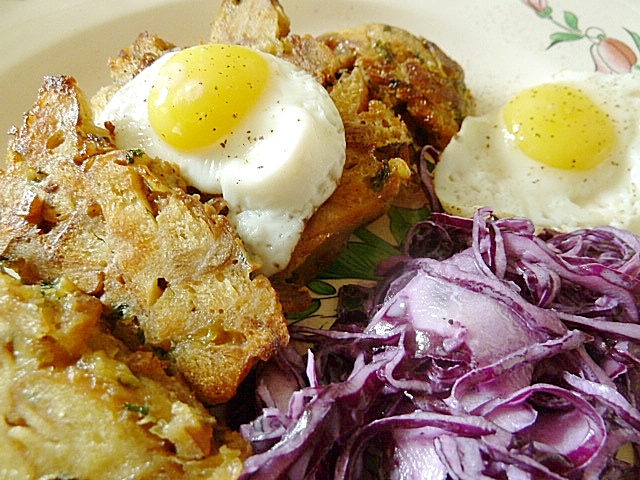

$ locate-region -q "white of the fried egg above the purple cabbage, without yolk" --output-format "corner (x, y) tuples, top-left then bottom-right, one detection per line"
(433, 71), (640, 234)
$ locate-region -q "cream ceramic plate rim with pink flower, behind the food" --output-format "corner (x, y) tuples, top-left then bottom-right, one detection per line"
(0, 0), (640, 156)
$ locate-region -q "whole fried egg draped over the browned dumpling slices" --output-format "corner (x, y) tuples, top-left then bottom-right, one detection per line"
(97, 44), (345, 275)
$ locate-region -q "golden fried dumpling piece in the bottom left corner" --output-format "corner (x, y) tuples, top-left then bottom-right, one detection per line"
(0, 271), (250, 480)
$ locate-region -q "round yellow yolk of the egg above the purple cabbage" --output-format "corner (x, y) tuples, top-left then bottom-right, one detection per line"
(503, 84), (616, 170)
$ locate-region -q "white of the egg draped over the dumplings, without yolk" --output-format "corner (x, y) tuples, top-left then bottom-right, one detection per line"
(96, 48), (345, 275)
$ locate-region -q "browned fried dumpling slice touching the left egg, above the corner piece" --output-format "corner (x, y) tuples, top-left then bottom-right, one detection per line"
(0, 77), (289, 403)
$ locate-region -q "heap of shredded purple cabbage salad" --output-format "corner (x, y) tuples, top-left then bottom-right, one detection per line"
(234, 204), (640, 480)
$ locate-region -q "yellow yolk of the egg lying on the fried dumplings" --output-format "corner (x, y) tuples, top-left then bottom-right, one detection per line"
(147, 44), (269, 150)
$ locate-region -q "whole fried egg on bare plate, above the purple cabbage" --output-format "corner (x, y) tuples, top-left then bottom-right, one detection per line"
(433, 71), (640, 233)
